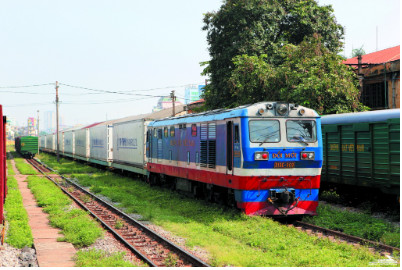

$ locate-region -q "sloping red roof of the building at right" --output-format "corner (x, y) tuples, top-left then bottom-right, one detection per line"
(343, 45), (401, 65)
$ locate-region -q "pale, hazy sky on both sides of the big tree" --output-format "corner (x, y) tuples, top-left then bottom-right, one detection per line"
(0, 0), (400, 129)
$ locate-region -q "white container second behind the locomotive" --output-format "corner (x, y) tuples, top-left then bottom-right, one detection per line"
(89, 125), (112, 161)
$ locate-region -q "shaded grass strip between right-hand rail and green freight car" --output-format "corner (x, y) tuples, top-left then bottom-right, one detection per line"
(304, 204), (400, 247)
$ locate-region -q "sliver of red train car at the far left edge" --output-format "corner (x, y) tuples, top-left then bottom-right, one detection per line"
(0, 105), (7, 224)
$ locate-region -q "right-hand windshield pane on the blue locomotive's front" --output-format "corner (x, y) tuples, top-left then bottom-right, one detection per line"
(286, 120), (317, 142)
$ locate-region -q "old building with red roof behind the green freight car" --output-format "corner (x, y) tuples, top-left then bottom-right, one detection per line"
(343, 46), (400, 110)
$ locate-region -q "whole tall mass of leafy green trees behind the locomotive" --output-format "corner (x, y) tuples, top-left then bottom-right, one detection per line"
(202, 0), (359, 112)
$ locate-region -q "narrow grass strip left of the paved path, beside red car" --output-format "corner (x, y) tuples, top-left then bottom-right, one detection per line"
(4, 176), (33, 248)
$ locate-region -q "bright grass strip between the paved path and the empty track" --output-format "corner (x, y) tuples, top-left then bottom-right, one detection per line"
(28, 176), (103, 247)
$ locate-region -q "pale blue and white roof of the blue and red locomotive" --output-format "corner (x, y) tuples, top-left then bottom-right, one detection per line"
(150, 101), (319, 126)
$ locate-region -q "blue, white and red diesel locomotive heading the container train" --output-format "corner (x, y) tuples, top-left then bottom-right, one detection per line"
(146, 102), (323, 215)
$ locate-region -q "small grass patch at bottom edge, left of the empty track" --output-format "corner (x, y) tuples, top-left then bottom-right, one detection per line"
(74, 249), (136, 267)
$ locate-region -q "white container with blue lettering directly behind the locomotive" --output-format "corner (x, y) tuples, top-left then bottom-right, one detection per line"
(112, 119), (146, 168)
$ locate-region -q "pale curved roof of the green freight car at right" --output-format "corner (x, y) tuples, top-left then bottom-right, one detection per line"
(321, 109), (401, 125)
